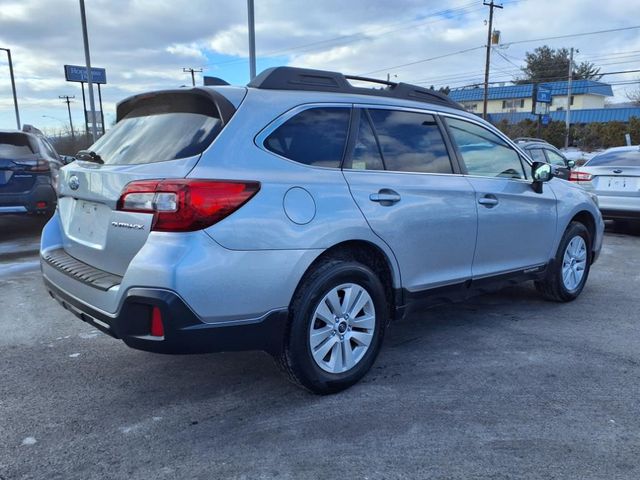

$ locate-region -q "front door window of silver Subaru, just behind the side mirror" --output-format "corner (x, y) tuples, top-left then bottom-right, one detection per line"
(446, 118), (526, 179)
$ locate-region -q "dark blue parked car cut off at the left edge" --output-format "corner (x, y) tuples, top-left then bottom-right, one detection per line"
(0, 126), (63, 215)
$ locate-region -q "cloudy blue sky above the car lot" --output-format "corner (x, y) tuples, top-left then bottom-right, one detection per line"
(0, 0), (640, 132)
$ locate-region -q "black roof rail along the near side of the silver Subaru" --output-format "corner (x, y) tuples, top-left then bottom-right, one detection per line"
(247, 67), (464, 110)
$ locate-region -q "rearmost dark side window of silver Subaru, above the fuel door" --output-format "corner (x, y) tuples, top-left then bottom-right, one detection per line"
(264, 107), (351, 168)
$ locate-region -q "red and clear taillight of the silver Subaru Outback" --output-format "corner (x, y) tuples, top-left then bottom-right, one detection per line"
(117, 179), (260, 232)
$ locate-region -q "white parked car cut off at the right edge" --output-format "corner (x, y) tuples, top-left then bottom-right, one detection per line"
(570, 145), (640, 221)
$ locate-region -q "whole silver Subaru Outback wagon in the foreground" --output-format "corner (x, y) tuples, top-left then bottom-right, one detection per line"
(41, 67), (603, 393)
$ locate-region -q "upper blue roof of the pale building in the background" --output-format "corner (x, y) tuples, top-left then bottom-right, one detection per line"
(449, 80), (613, 102)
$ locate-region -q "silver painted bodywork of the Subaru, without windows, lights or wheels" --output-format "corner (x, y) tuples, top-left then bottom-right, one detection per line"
(42, 87), (602, 323)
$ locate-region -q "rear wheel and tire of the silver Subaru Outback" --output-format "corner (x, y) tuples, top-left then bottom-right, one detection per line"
(276, 259), (389, 394)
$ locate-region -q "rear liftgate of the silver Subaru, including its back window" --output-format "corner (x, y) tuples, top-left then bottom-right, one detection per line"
(58, 89), (235, 275)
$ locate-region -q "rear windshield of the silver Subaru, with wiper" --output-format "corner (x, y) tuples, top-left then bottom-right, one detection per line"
(89, 94), (222, 165)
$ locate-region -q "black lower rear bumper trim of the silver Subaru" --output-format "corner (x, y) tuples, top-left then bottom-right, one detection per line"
(44, 277), (288, 354)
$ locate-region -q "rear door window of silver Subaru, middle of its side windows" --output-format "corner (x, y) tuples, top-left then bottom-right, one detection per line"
(369, 109), (453, 173)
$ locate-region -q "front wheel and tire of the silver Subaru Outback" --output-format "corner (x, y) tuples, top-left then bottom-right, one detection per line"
(535, 222), (592, 302)
